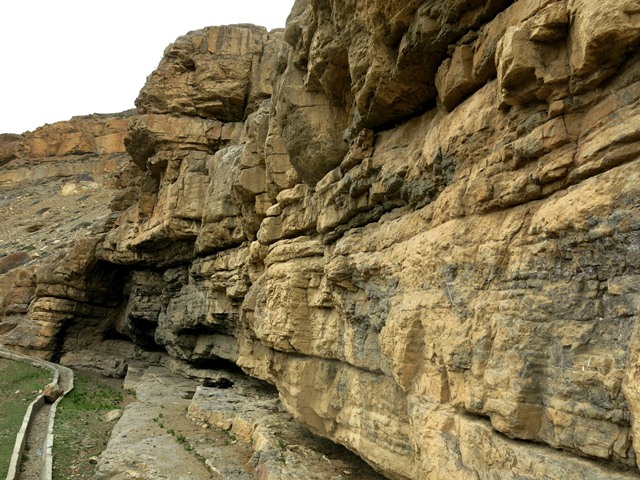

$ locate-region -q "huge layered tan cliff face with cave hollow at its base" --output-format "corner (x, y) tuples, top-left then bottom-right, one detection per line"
(2, 0), (640, 479)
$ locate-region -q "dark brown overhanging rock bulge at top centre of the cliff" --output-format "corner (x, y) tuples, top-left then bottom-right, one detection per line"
(285, 1), (509, 133)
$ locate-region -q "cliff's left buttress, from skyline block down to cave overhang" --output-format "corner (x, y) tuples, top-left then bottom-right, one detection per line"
(100, 26), (290, 265)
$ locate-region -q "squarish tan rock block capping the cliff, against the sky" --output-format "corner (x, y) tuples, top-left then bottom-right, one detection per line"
(136, 25), (278, 122)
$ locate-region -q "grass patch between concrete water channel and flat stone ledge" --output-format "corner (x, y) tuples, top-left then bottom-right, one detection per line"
(53, 372), (123, 480)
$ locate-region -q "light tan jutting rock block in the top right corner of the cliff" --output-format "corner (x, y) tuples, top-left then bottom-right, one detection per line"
(496, 1), (640, 105)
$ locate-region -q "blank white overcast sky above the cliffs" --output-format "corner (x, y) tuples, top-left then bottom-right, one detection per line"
(0, 0), (294, 133)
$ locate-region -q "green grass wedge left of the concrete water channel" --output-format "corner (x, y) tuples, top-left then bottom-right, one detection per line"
(0, 358), (52, 478)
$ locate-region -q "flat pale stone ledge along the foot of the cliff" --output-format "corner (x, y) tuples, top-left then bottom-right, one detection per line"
(94, 367), (384, 480)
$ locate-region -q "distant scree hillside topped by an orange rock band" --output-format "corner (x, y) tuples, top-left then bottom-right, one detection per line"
(0, 112), (137, 324)
